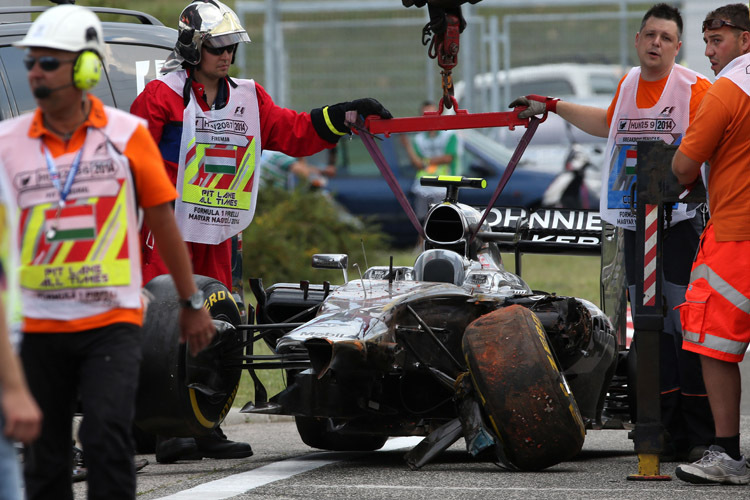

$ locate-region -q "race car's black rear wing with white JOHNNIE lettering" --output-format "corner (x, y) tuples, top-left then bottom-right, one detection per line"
(477, 207), (614, 255)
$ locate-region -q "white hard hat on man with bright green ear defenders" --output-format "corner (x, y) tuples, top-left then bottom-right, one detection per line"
(13, 4), (104, 58)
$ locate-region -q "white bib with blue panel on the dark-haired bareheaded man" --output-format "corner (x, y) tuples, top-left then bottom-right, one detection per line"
(599, 64), (700, 230)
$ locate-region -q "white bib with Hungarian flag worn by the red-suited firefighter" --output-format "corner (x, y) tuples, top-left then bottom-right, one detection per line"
(160, 71), (261, 245)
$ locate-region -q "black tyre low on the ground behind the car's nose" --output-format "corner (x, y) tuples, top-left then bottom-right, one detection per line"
(294, 417), (388, 451)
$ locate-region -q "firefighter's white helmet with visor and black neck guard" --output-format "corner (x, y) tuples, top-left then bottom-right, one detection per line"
(175, 0), (250, 65)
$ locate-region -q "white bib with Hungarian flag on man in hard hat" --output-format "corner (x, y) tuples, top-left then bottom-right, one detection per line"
(0, 107), (141, 320)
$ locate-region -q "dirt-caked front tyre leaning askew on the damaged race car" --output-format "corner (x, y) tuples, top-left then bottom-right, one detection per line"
(463, 305), (585, 470)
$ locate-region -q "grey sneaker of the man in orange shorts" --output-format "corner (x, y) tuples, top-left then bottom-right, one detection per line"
(675, 446), (750, 484)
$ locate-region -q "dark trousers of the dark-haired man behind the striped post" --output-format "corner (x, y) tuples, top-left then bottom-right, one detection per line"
(625, 221), (714, 451)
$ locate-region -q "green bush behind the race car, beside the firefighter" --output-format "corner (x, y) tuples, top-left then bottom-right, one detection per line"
(242, 186), (394, 286)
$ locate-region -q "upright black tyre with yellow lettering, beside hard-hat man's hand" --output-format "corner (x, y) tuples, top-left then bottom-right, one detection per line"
(135, 275), (244, 437)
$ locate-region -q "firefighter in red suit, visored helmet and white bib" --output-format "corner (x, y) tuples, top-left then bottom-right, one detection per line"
(131, 0), (391, 462)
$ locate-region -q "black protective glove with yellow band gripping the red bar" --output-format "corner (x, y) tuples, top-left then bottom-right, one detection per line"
(310, 97), (393, 142)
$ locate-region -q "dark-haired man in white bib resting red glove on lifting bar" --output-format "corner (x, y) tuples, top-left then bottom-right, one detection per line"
(511, 3), (713, 461)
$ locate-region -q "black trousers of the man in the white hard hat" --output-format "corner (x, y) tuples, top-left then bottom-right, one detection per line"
(21, 323), (141, 500)
